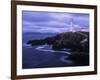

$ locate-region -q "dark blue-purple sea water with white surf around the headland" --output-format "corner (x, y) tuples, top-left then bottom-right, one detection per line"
(22, 33), (89, 69)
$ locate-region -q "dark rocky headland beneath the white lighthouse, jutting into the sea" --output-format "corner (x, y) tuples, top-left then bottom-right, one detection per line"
(27, 32), (89, 52)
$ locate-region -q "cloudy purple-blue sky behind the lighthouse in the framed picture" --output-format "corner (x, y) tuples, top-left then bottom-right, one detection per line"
(22, 11), (89, 33)
